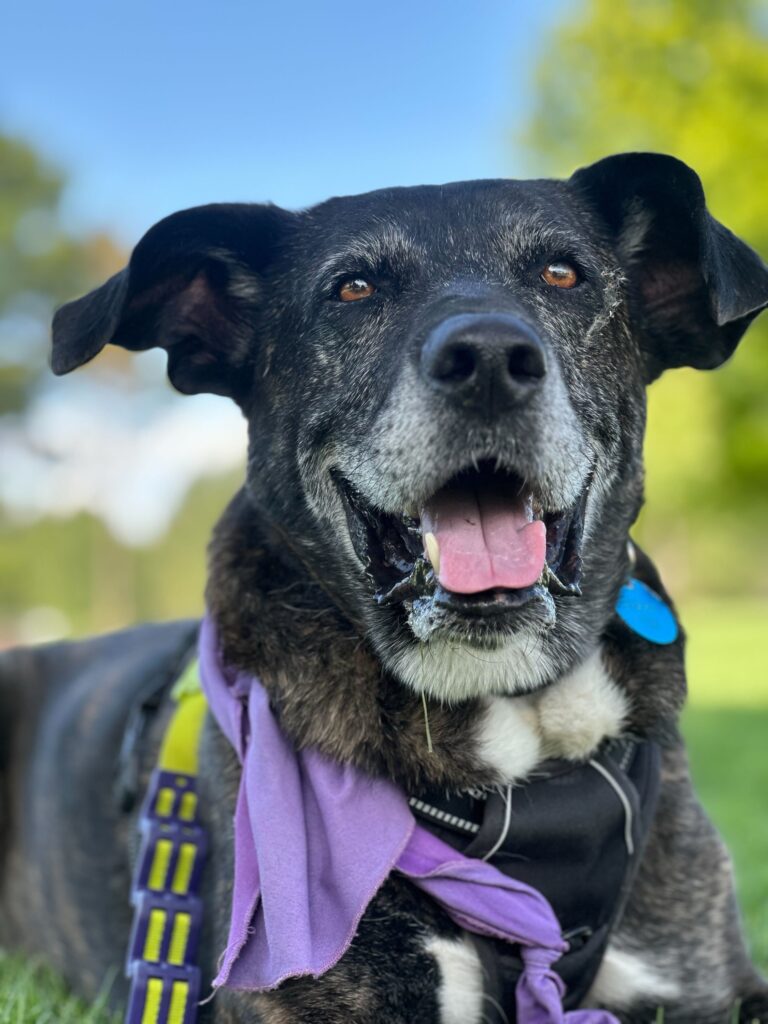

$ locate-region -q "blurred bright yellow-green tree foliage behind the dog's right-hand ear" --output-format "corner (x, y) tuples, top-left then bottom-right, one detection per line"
(524, 0), (768, 593)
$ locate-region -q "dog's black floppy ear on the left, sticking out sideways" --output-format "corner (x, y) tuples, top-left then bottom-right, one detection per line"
(51, 204), (294, 400)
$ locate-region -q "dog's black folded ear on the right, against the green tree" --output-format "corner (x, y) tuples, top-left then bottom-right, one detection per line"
(570, 153), (768, 381)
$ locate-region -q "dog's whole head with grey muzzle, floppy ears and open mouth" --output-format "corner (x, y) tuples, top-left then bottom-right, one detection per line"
(53, 155), (768, 700)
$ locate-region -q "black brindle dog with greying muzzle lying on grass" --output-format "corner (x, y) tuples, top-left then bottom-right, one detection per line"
(0, 154), (768, 1024)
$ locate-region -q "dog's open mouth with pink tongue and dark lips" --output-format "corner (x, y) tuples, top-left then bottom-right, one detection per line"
(337, 463), (589, 616)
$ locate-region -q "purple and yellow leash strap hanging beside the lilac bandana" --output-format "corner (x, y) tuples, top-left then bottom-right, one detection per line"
(125, 659), (207, 1024)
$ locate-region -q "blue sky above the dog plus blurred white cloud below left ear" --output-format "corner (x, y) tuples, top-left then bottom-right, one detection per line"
(0, 0), (572, 544)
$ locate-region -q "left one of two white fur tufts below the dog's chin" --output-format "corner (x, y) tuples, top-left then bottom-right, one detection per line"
(477, 697), (543, 784)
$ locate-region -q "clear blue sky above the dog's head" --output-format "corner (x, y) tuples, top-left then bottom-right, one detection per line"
(0, 0), (564, 243)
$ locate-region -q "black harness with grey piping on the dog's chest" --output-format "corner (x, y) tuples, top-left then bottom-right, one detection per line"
(410, 736), (660, 1024)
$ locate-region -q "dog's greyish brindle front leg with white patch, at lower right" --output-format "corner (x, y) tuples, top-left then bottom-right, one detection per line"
(586, 742), (768, 1024)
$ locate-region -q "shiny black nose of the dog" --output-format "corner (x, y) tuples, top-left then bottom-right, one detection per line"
(421, 313), (547, 415)
